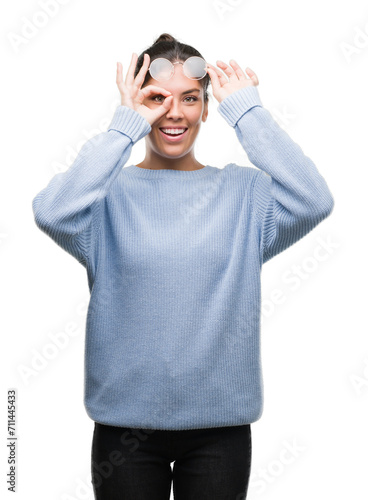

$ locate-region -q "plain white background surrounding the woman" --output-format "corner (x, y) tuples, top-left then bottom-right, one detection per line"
(0, 0), (368, 500)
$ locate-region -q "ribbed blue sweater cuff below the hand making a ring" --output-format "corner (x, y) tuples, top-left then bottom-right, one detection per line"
(107, 106), (151, 144)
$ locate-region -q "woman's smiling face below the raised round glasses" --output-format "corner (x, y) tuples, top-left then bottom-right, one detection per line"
(143, 64), (208, 158)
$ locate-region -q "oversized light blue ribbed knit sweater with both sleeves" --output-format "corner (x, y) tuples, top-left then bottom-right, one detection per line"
(32, 86), (334, 430)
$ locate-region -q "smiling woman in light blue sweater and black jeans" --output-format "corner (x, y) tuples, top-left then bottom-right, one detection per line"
(33, 34), (334, 500)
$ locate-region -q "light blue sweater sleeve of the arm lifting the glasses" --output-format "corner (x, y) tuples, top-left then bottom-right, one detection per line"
(218, 86), (334, 263)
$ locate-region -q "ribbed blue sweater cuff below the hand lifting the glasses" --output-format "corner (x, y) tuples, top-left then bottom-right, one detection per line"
(217, 85), (263, 127)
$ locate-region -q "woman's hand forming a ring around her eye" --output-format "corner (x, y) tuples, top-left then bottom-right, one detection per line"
(116, 53), (173, 126)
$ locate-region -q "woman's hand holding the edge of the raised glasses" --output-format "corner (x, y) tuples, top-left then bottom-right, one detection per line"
(207, 59), (259, 102)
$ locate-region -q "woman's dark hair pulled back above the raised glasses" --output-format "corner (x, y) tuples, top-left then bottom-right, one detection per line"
(134, 33), (211, 102)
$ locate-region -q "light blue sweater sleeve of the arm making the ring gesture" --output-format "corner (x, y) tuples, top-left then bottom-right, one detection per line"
(32, 106), (151, 265)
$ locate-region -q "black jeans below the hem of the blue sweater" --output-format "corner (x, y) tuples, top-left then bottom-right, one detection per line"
(91, 422), (252, 500)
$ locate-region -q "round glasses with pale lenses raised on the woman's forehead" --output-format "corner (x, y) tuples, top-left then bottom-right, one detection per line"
(148, 56), (207, 82)
